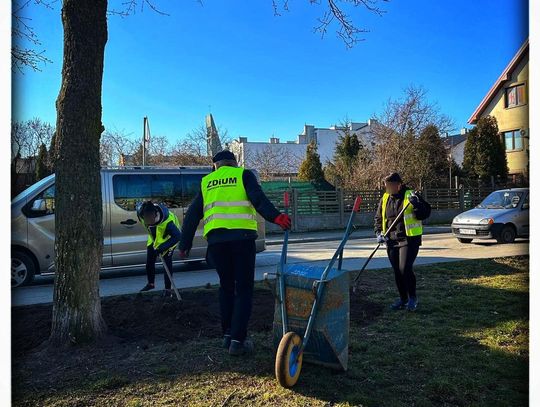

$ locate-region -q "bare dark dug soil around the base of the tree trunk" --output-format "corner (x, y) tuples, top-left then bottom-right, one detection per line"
(11, 288), (274, 358)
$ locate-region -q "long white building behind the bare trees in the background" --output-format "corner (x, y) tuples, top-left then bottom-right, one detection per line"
(230, 119), (377, 174)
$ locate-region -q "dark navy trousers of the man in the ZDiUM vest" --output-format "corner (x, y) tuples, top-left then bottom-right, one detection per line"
(208, 240), (255, 342)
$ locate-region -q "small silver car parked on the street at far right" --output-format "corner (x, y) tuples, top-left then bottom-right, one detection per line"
(452, 188), (529, 243)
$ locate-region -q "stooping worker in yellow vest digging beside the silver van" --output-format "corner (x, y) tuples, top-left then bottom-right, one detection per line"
(137, 201), (180, 296)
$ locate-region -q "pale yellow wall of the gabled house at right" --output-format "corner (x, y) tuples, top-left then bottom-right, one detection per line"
(482, 53), (529, 175)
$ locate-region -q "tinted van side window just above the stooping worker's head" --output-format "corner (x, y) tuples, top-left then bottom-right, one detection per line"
(113, 174), (182, 211)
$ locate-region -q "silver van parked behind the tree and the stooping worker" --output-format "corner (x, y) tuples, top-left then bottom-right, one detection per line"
(11, 167), (265, 287)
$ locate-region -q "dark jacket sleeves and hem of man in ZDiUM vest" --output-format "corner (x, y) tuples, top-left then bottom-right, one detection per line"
(180, 170), (279, 250)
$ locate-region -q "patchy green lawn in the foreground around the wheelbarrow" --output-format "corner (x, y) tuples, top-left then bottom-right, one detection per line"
(14, 257), (529, 407)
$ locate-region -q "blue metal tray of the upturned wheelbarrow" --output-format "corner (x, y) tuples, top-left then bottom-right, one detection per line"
(273, 264), (350, 371)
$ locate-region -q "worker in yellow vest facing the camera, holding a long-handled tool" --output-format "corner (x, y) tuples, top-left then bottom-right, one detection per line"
(375, 172), (431, 311)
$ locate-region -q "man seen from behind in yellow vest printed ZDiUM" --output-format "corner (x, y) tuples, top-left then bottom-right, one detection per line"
(179, 151), (291, 356)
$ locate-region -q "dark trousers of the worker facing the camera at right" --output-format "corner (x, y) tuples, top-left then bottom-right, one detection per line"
(386, 241), (420, 301)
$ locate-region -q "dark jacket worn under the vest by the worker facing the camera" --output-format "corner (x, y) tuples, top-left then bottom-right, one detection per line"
(374, 185), (431, 246)
